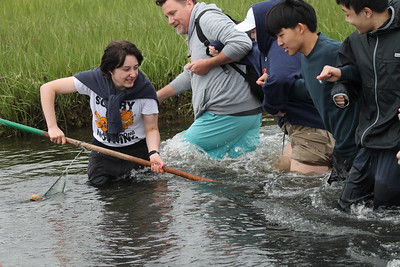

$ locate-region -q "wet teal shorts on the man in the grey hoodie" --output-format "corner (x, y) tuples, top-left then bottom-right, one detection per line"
(183, 112), (261, 159)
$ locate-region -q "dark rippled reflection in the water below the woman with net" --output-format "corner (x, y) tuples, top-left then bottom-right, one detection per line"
(98, 178), (172, 266)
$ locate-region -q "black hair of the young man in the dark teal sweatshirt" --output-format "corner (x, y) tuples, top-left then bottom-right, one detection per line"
(265, 0), (317, 37)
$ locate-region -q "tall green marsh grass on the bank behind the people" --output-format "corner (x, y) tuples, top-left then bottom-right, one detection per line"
(0, 0), (351, 134)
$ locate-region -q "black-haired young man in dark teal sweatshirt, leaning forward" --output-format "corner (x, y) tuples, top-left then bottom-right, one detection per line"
(265, 0), (359, 183)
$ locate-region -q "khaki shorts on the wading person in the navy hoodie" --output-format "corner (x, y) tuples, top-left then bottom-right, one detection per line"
(282, 122), (335, 167)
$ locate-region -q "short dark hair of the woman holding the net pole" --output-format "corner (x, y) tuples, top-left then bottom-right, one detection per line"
(100, 41), (143, 77)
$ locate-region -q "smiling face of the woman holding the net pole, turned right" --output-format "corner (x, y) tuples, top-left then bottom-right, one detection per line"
(111, 55), (139, 90)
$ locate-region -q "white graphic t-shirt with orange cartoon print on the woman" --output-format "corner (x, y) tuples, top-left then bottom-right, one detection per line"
(74, 78), (158, 147)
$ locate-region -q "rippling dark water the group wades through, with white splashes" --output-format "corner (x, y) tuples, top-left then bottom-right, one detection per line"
(0, 126), (400, 267)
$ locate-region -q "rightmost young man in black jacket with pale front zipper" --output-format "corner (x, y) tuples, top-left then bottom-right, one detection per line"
(317, 0), (400, 210)
